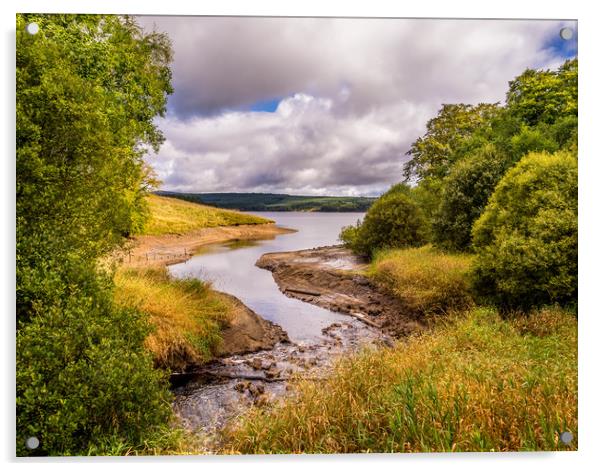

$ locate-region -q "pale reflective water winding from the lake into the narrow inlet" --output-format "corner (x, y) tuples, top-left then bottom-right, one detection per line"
(169, 212), (363, 343)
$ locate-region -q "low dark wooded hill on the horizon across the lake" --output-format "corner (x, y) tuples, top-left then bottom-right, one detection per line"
(156, 191), (376, 212)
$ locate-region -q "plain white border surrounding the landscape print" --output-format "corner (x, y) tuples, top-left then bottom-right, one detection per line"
(0, 0), (602, 471)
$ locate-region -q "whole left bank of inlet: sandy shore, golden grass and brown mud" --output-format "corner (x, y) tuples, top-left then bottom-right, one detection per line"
(115, 221), (295, 372)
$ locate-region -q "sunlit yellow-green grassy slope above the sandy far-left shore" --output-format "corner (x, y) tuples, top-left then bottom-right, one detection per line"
(143, 195), (274, 235)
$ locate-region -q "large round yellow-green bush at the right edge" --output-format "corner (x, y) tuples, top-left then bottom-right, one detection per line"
(472, 151), (577, 308)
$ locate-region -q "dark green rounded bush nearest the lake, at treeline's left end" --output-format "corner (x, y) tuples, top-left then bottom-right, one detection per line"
(340, 187), (428, 255)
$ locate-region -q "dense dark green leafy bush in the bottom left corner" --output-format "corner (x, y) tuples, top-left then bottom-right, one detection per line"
(16, 267), (171, 456)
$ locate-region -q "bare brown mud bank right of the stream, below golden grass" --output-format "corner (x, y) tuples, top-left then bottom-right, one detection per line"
(257, 246), (424, 337)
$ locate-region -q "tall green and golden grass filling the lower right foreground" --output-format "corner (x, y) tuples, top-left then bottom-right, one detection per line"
(223, 308), (577, 453)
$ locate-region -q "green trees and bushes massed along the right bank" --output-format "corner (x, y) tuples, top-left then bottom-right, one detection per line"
(341, 59), (578, 309)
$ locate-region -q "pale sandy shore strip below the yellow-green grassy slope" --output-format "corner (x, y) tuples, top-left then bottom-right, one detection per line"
(116, 224), (296, 268)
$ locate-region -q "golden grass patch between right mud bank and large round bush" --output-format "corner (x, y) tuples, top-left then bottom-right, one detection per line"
(368, 246), (472, 316)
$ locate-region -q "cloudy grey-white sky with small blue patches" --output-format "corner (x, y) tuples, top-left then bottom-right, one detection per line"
(138, 16), (577, 196)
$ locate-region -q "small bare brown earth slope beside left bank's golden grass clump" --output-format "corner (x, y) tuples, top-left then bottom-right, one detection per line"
(217, 292), (289, 357)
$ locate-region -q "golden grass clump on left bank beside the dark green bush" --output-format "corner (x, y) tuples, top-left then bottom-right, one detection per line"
(115, 267), (233, 370)
